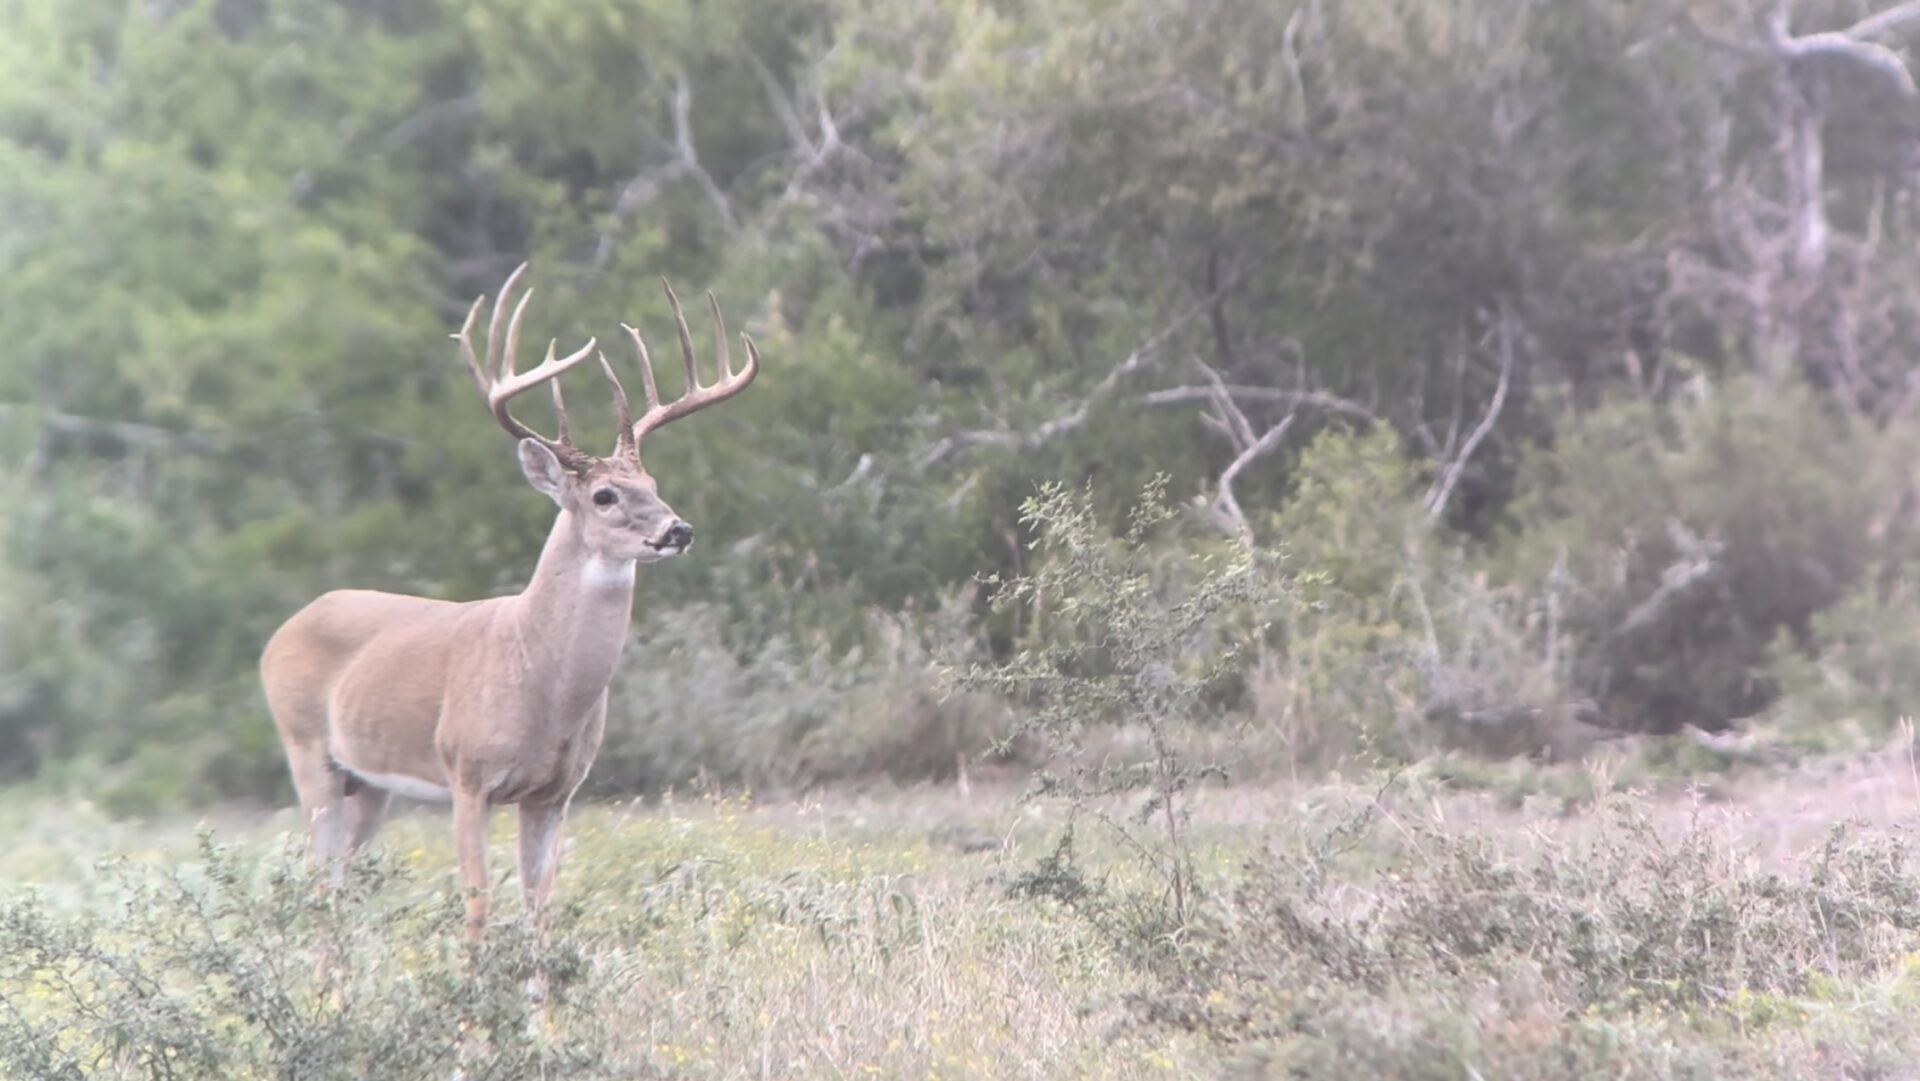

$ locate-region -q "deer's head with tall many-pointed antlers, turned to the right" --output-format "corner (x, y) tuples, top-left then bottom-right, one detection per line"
(455, 263), (760, 563)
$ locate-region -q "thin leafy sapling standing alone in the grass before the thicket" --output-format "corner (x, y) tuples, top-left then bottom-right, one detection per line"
(956, 480), (1273, 937)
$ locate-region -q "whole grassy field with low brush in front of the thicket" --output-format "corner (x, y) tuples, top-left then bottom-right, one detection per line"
(0, 747), (1920, 1079)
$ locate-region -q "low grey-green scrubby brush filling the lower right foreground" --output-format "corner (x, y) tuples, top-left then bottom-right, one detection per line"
(1175, 791), (1920, 1079)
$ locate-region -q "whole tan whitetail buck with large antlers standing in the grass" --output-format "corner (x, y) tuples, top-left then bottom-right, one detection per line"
(259, 263), (760, 939)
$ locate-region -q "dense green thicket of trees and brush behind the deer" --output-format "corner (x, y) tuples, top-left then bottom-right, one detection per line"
(0, 0), (1920, 808)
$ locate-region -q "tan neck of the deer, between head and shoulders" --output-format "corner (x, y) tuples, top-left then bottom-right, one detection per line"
(511, 511), (634, 716)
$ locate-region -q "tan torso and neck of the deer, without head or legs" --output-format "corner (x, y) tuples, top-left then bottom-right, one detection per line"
(261, 515), (634, 803)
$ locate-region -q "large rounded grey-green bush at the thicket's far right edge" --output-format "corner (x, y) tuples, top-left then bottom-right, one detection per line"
(1511, 382), (1912, 732)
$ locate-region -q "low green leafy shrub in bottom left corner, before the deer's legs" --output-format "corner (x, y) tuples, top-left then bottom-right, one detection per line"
(0, 833), (609, 1081)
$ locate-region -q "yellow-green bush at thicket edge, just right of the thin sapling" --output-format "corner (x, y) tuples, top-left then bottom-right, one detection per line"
(1246, 430), (1584, 772)
